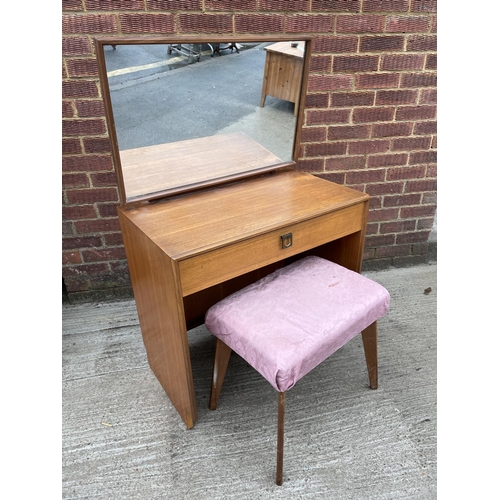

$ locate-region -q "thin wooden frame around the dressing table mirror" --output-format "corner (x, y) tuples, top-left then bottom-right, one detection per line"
(94, 34), (312, 206)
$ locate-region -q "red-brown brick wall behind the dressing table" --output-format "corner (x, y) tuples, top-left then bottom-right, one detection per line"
(62, 0), (437, 300)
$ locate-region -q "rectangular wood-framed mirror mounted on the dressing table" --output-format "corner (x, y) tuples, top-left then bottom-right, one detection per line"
(95, 37), (309, 204)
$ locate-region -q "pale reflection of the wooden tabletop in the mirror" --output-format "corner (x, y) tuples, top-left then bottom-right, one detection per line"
(120, 132), (284, 205)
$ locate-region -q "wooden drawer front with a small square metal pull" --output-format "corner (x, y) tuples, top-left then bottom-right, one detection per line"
(179, 203), (364, 296)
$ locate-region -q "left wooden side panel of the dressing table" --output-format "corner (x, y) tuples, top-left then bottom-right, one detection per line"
(118, 209), (197, 428)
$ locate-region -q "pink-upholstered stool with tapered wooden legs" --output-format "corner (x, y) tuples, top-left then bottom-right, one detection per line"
(205, 256), (390, 485)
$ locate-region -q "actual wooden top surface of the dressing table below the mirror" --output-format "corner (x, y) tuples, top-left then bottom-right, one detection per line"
(119, 170), (369, 260)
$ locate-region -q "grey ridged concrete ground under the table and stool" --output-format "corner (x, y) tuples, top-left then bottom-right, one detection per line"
(62, 264), (437, 500)
